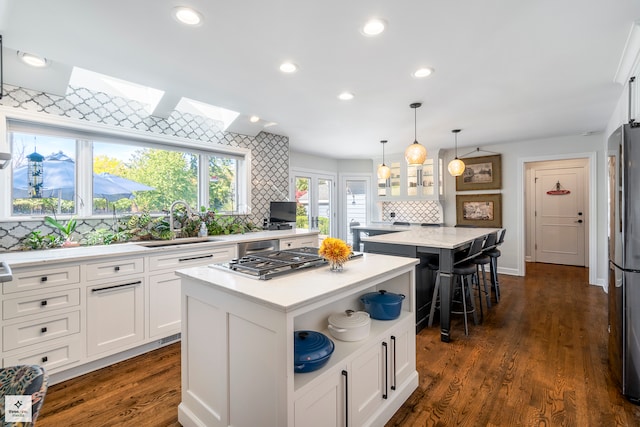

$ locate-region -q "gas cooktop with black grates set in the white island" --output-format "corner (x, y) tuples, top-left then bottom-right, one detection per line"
(209, 247), (361, 280)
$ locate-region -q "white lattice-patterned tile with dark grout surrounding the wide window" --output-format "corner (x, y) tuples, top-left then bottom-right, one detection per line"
(0, 84), (289, 251)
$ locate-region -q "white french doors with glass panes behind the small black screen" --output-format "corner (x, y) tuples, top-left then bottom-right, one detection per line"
(291, 170), (337, 239)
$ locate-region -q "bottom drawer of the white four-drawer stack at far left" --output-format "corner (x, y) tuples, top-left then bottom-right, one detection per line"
(4, 339), (82, 373)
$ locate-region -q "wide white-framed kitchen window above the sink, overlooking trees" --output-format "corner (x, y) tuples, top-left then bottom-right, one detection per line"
(0, 112), (250, 218)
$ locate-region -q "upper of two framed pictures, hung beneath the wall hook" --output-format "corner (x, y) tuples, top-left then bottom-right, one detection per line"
(456, 154), (502, 191)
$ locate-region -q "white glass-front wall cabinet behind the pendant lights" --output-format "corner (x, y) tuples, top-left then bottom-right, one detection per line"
(374, 151), (443, 200)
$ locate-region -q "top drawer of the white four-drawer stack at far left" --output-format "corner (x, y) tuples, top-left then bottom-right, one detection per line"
(2, 265), (80, 294)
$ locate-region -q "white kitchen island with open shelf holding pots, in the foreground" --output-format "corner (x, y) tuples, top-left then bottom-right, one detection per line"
(177, 254), (418, 427)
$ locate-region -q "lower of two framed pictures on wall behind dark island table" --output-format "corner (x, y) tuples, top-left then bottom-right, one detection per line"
(456, 194), (502, 228)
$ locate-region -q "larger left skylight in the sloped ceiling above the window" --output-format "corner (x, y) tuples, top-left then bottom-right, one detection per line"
(67, 67), (164, 114)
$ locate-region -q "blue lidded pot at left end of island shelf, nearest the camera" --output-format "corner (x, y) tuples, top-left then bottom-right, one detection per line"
(293, 331), (335, 372)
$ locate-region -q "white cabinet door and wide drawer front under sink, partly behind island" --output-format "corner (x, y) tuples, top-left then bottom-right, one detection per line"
(148, 244), (237, 338)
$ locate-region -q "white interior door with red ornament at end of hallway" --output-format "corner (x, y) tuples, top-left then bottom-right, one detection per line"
(535, 167), (586, 266)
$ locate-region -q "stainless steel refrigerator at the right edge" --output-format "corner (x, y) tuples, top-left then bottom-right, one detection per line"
(607, 125), (640, 404)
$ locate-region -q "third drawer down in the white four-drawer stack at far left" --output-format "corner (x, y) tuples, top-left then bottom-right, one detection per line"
(2, 311), (80, 351)
